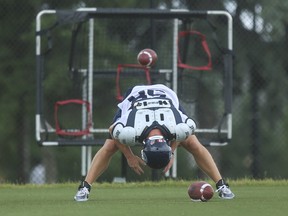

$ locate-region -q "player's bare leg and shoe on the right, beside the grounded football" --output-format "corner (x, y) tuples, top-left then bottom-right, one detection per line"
(180, 135), (234, 199)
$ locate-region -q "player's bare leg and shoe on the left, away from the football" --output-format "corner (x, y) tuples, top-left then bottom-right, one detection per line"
(74, 139), (118, 201)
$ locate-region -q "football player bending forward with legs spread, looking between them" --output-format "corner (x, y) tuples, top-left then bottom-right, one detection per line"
(74, 84), (234, 201)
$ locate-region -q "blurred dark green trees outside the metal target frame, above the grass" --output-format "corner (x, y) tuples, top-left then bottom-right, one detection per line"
(0, 0), (288, 182)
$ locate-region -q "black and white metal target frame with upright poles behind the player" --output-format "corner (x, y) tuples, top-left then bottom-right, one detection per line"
(35, 8), (233, 177)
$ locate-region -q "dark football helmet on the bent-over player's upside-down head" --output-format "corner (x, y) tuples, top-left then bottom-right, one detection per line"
(141, 135), (172, 169)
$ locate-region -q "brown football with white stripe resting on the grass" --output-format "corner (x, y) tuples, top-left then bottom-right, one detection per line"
(188, 181), (214, 202)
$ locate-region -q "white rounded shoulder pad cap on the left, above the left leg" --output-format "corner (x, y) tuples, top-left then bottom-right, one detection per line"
(112, 123), (136, 146)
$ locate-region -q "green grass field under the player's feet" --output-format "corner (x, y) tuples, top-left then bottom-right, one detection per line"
(0, 180), (288, 216)
